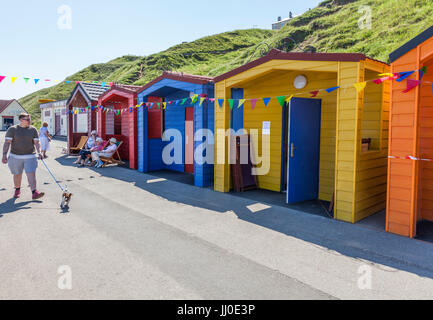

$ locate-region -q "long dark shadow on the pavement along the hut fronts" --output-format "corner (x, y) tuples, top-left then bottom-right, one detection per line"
(56, 156), (433, 279)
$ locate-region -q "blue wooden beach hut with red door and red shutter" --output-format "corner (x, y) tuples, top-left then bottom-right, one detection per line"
(138, 72), (214, 187)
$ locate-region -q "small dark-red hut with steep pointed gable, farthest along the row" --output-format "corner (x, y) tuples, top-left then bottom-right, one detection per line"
(66, 82), (110, 154)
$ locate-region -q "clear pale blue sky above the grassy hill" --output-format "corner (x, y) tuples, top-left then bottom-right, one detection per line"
(0, 0), (321, 99)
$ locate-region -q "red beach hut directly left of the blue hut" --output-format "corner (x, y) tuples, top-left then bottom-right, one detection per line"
(98, 84), (141, 169)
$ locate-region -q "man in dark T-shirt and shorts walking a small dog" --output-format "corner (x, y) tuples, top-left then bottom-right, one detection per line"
(2, 113), (44, 200)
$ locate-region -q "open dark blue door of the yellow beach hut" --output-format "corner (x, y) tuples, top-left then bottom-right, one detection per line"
(287, 98), (322, 203)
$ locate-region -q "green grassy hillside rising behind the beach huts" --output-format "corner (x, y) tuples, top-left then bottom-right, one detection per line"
(20, 0), (433, 119)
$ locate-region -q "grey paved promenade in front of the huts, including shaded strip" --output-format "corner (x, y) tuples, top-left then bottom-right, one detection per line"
(0, 133), (433, 299)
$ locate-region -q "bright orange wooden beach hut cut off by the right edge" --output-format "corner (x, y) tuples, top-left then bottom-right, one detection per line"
(386, 27), (433, 237)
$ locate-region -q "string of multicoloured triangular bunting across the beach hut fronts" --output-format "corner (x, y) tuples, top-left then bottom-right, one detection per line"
(70, 67), (426, 116)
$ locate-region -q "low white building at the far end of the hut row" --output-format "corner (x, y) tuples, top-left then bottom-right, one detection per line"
(39, 100), (68, 137)
